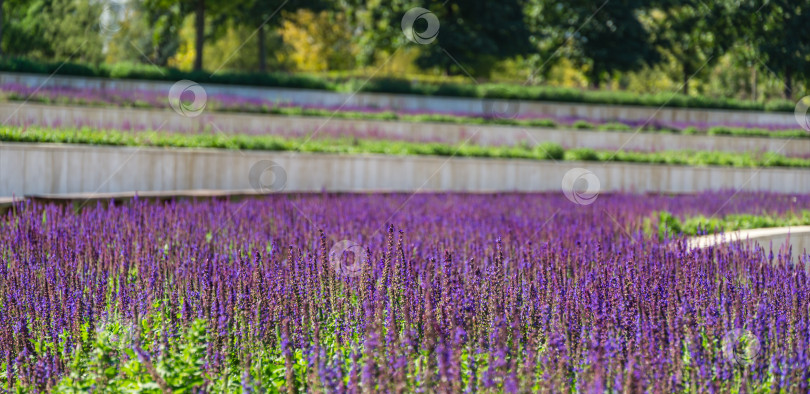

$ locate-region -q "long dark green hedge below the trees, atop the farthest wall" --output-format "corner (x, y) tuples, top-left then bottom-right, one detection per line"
(0, 57), (794, 112)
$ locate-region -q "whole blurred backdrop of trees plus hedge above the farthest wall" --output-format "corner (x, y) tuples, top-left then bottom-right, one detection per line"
(0, 0), (810, 110)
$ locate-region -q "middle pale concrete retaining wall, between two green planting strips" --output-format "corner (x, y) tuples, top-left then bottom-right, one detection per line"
(0, 103), (810, 155)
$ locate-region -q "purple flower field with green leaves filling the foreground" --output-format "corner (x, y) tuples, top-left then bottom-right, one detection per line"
(0, 193), (810, 393)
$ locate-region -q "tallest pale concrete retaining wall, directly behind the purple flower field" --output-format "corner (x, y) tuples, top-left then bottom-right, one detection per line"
(0, 143), (810, 197)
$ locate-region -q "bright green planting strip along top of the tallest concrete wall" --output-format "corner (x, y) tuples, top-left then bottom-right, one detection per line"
(0, 126), (810, 168)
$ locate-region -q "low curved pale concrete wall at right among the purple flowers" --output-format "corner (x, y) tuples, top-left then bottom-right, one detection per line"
(688, 226), (810, 269)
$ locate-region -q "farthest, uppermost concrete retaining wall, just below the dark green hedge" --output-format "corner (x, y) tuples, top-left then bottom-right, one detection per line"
(0, 73), (798, 128)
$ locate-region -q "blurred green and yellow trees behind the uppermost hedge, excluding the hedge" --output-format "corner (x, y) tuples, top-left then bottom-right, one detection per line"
(0, 0), (810, 102)
